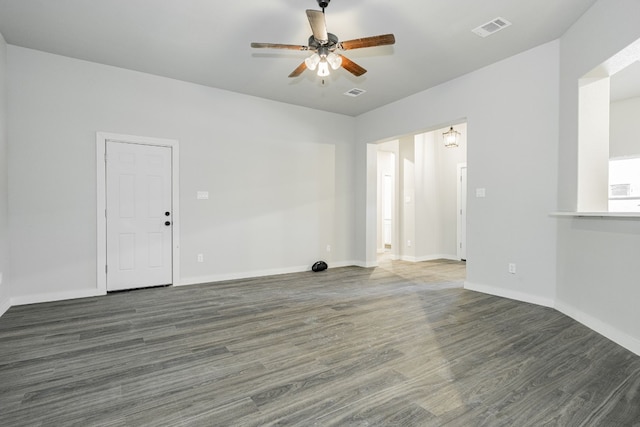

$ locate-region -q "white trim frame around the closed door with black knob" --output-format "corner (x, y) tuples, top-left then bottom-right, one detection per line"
(96, 132), (180, 294)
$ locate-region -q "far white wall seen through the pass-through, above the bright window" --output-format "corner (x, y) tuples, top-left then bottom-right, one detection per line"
(609, 97), (640, 158)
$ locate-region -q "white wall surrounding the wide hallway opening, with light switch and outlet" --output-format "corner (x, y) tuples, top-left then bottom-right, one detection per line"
(356, 41), (559, 305)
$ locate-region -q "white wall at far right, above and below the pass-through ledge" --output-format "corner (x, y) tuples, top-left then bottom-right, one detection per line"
(556, 0), (640, 354)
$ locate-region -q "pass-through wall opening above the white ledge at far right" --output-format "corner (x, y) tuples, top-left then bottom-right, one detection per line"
(577, 39), (640, 212)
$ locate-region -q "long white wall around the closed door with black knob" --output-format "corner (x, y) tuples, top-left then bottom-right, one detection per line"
(8, 46), (354, 303)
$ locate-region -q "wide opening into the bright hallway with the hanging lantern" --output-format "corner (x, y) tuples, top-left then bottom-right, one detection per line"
(368, 123), (467, 263)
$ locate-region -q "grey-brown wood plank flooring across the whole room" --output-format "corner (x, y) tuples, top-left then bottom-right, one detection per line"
(0, 261), (640, 427)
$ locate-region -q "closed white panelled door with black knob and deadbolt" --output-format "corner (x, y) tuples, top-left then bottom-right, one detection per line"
(106, 141), (173, 291)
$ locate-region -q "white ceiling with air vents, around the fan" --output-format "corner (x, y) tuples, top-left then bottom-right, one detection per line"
(0, 0), (596, 116)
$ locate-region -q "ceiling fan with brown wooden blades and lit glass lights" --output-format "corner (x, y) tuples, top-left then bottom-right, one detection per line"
(251, 0), (396, 77)
